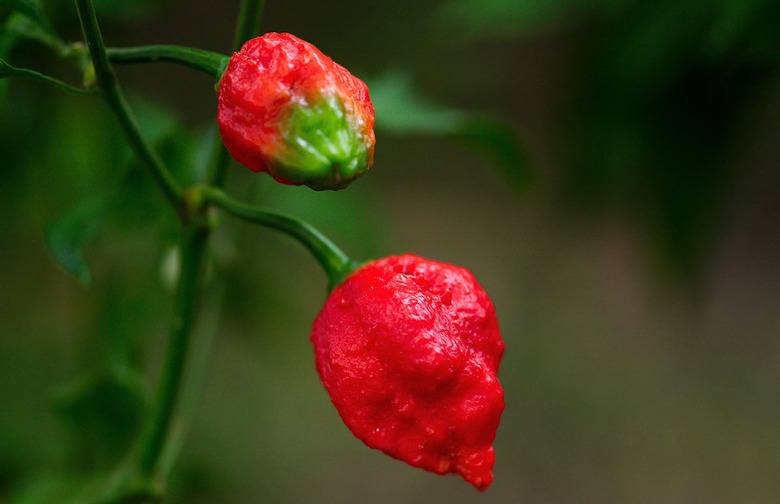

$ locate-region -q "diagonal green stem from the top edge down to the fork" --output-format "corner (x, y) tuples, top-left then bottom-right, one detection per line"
(76, 0), (183, 209)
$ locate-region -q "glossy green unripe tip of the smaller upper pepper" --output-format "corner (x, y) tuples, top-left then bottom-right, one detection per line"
(274, 95), (371, 191)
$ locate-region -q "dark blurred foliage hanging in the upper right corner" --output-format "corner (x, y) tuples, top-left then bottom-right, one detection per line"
(437, 0), (780, 281)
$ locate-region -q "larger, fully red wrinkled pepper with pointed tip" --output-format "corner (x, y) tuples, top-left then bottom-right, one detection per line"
(311, 254), (504, 490)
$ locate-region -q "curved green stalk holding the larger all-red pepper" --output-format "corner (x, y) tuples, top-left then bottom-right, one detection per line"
(200, 187), (358, 288)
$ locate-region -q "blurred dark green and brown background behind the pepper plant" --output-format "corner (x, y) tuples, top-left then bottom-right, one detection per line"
(0, 0), (780, 504)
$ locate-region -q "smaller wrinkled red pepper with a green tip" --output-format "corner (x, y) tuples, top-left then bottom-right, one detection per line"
(217, 33), (375, 190)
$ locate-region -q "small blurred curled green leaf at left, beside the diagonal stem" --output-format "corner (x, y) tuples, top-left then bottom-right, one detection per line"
(45, 195), (107, 287)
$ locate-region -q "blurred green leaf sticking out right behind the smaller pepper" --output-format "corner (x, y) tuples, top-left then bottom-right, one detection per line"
(368, 70), (530, 189)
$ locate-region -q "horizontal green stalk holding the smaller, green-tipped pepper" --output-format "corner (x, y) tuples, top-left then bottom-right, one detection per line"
(106, 45), (230, 79)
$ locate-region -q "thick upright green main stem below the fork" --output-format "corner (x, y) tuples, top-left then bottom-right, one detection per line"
(133, 225), (209, 478)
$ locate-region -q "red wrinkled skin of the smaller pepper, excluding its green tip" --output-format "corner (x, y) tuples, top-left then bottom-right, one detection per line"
(217, 33), (375, 189)
